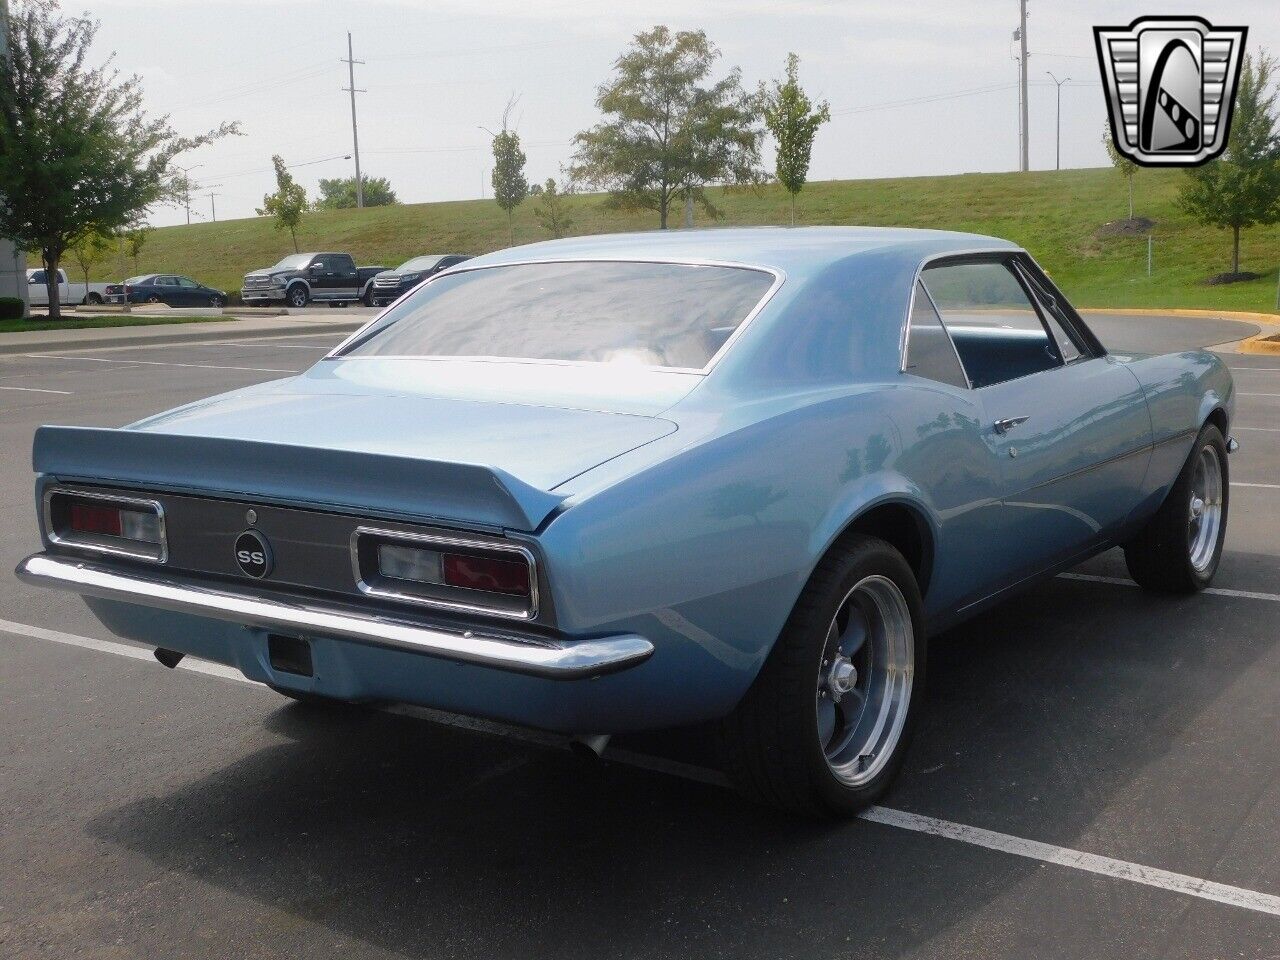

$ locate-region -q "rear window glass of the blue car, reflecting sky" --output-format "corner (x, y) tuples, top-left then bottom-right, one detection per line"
(340, 261), (773, 370)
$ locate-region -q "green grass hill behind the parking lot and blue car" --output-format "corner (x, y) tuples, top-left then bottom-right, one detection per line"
(90, 168), (1280, 311)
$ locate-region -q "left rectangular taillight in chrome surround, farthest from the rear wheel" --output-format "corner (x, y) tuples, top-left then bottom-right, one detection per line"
(45, 489), (168, 562)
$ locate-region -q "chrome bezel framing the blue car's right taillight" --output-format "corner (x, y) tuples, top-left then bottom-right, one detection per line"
(351, 526), (539, 621)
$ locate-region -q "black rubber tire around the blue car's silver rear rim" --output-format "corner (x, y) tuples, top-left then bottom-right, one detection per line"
(721, 535), (927, 817)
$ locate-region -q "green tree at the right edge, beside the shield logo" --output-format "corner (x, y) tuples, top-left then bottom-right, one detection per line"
(1178, 50), (1280, 274)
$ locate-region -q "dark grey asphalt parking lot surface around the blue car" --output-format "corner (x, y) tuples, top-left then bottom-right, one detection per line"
(0, 317), (1280, 960)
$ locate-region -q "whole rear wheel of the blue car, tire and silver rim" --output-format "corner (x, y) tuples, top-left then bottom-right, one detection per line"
(722, 536), (925, 817)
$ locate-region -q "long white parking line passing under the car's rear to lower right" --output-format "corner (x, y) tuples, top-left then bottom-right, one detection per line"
(0, 619), (1280, 916)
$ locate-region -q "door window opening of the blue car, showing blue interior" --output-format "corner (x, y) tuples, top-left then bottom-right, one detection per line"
(920, 260), (1062, 387)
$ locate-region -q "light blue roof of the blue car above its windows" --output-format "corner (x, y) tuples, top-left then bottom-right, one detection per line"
(467, 227), (1020, 280)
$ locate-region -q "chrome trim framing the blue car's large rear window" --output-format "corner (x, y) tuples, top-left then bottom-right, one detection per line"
(321, 256), (787, 376)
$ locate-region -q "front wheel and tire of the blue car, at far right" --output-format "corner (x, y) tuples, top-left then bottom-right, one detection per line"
(1124, 424), (1231, 594)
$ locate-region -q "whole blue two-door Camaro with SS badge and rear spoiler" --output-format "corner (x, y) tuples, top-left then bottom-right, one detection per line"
(18, 228), (1234, 814)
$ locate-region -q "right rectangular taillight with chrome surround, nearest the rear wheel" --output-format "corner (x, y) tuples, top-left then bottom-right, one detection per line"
(352, 527), (538, 620)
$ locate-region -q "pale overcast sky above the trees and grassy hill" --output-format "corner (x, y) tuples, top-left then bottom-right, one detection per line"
(77, 0), (1280, 225)
